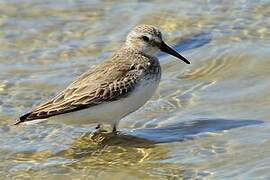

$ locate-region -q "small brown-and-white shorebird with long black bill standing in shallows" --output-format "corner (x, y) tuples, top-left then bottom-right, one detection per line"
(15, 25), (190, 132)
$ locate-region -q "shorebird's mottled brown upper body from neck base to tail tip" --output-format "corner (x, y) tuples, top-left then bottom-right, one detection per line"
(16, 47), (160, 124)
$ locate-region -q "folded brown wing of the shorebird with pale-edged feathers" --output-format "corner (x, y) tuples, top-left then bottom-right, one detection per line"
(15, 55), (148, 124)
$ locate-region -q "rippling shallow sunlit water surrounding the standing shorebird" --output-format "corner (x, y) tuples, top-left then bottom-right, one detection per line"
(0, 0), (270, 179)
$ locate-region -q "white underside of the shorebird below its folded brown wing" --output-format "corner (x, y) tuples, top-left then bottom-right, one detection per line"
(49, 79), (159, 126)
